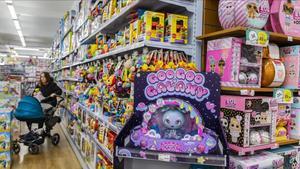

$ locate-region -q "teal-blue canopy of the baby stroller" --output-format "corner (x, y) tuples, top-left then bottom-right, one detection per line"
(14, 96), (45, 121)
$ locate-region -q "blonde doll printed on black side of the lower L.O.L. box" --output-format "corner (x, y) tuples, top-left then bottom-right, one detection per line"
(229, 116), (242, 143)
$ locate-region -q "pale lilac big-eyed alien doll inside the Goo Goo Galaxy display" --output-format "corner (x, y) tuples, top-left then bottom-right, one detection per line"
(162, 109), (185, 140)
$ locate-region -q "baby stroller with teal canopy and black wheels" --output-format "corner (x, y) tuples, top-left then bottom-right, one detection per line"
(12, 96), (64, 154)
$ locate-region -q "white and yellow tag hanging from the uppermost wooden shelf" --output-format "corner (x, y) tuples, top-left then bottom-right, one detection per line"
(246, 29), (270, 47)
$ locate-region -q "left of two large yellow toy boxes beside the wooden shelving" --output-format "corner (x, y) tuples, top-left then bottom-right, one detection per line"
(139, 11), (165, 42)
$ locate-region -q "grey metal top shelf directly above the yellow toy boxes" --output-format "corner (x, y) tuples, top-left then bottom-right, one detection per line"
(82, 0), (194, 44)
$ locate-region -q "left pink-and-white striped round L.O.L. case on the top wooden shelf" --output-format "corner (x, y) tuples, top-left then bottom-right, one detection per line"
(218, 0), (270, 29)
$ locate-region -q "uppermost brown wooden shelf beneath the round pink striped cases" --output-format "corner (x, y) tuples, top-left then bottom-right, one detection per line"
(197, 26), (300, 46)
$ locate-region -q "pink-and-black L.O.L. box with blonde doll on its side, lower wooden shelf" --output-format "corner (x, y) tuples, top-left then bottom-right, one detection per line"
(221, 95), (277, 155)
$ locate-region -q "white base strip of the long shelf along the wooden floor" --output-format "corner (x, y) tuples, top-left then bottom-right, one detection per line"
(60, 123), (91, 169)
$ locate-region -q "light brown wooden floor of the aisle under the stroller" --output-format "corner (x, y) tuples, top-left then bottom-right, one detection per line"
(12, 125), (81, 169)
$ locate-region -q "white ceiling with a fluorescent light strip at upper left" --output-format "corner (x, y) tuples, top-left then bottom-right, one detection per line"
(0, 0), (77, 55)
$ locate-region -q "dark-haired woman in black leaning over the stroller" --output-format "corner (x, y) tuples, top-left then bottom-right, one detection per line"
(33, 72), (62, 110)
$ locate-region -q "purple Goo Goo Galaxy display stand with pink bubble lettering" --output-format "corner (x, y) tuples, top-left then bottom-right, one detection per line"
(114, 68), (226, 166)
